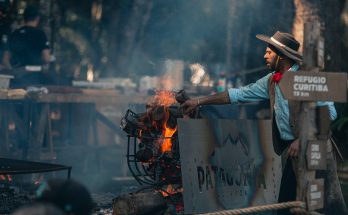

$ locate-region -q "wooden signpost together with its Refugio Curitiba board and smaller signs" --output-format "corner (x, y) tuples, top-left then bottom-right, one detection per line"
(279, 22), (347, 215)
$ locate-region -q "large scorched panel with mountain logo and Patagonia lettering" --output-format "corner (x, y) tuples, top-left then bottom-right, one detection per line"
(178, 119), (282, 214)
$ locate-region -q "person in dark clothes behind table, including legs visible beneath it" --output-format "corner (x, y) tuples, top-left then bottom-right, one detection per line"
(3, 5), (51, 160)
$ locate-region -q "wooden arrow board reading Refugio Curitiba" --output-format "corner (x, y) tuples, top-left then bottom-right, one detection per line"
(279, 71), (347, 102)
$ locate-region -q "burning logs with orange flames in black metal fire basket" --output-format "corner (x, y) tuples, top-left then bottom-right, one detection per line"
(118, 91), (197, 213)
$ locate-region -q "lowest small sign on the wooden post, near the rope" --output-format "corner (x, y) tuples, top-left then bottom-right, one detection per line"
(307, 179), (324, 211)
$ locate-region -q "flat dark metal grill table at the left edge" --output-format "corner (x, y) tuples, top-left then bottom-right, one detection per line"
(0, 158), (72, 179)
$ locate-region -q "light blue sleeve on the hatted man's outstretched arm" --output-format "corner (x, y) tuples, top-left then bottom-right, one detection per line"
(228, 73), (272, 104)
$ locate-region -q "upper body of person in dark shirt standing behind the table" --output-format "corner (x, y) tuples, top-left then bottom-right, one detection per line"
(4, 6), (50, 87)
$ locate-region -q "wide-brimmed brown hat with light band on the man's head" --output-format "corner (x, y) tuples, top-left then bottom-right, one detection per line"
(256, 31), (302, 62)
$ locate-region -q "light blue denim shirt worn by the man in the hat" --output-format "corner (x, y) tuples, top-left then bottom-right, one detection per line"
(228, 64), (337, 140)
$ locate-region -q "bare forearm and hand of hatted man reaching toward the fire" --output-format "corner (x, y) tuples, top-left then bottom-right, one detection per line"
(181, 91), (231, 114)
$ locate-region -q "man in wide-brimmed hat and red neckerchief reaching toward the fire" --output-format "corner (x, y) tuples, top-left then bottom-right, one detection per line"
(182, 31), (347, 214)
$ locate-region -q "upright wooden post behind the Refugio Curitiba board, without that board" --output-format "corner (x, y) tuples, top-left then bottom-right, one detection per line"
(297, 21), (326, 212)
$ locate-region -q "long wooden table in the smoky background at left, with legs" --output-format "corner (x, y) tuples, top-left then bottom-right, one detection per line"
(0, 87), (147, 160)
